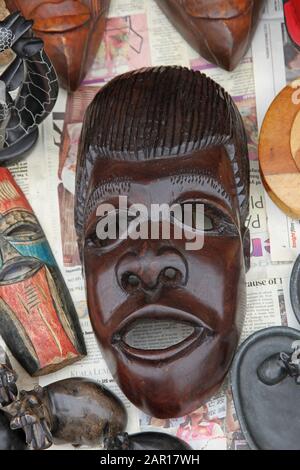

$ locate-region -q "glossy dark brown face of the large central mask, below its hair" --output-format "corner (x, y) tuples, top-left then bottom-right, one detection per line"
(84, 147), (245, 417)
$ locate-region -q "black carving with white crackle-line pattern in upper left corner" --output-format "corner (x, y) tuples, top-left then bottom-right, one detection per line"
(0, 13), (58, 162)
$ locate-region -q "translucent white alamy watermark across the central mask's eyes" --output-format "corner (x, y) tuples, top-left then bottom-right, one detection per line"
(96, 196), (206, 250)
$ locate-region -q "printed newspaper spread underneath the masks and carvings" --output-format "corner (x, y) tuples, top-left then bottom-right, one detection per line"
(0, 0), (300, 450)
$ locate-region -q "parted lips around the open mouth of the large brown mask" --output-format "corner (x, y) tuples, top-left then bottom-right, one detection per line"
(111, 305), (215, 362)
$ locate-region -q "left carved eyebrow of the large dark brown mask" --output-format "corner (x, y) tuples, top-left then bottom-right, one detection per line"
(85, 178), (131, 219)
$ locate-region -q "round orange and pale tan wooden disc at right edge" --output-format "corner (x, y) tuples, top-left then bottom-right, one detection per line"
(259, 80), (300, 218)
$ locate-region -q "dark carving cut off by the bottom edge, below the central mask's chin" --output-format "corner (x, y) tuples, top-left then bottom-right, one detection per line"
(105, 432), (192, 450)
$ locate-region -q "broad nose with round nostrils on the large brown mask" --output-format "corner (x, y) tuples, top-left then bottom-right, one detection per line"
(117, 247), (187, 294)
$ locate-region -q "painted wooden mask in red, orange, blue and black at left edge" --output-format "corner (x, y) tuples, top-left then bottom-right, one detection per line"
(0, 168), (86, 376)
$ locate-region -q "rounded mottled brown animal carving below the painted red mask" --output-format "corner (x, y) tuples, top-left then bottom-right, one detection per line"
(4, 378), (127, 450)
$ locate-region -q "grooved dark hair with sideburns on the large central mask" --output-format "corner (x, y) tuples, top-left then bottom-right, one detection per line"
(75, 67), (249, 239)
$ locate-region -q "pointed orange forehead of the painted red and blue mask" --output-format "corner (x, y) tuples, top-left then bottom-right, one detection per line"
(0, 168), (32, 216)
